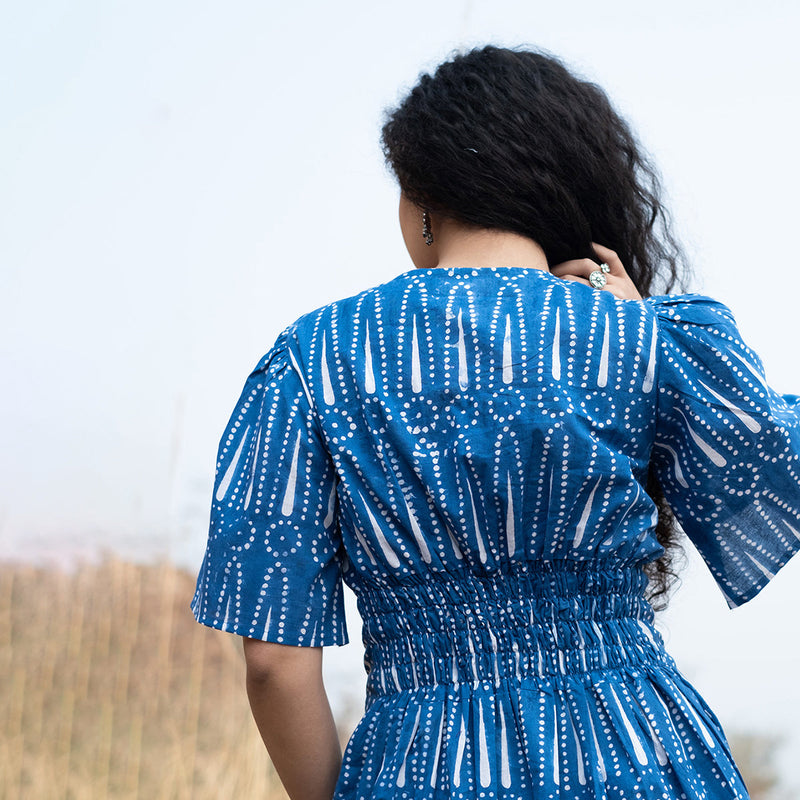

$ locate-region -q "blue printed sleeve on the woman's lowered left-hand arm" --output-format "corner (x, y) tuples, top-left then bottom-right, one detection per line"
(191, 326), (348, 646)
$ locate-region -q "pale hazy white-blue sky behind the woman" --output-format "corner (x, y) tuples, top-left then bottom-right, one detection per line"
(0, 0), (800, 785)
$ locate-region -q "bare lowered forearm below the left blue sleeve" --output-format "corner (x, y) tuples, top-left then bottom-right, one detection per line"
(242, 638), (342, 800)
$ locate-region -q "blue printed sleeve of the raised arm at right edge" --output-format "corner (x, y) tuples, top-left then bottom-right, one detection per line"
(648, 294), (800, 608)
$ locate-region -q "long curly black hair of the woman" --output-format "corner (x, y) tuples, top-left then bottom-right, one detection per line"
(382, 45), (689, 609)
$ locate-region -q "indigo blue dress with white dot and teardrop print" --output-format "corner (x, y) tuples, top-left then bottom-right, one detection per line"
(192, 267), (800, 800)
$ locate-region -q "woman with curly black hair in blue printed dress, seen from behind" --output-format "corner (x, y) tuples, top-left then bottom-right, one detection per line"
(192, 47), (800, 800)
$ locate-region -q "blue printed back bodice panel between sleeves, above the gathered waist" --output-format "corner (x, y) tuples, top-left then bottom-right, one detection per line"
(290, 267), (658, 582)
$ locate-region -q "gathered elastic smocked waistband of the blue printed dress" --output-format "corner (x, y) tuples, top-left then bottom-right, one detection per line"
(355, 561), (670, 696)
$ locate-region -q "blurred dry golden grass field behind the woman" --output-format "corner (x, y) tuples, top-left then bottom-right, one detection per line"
(0, 561), (794, 800)
